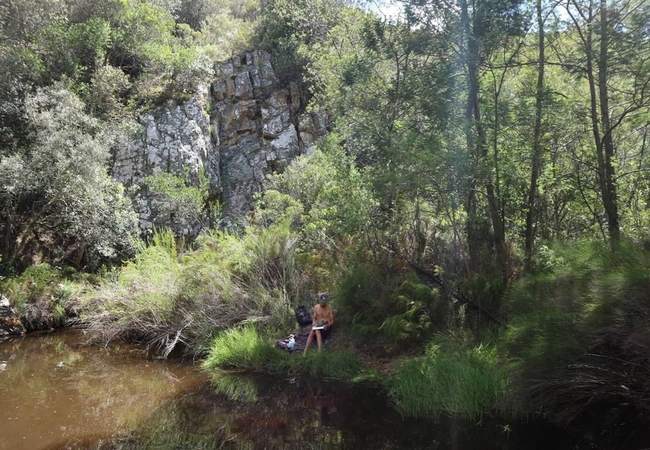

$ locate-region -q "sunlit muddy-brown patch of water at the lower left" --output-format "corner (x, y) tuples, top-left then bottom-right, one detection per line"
(0, 333), (205, 450)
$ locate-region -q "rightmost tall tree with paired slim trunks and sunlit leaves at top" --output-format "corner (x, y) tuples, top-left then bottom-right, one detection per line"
(565, 0), (650, 242)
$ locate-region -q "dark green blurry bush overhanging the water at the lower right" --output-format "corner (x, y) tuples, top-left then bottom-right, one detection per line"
(503, 242), (650, 422)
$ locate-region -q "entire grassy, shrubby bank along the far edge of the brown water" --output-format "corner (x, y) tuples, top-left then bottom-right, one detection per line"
(3, 239), (650, 429)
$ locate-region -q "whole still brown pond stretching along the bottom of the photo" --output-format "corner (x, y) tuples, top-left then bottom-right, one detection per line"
(0, 331), (638, 450)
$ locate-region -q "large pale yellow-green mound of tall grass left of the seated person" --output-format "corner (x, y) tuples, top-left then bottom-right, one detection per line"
(83, 224), (305, 356)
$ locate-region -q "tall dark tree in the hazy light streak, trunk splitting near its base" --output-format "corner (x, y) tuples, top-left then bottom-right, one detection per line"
(408, 0), (525, 265)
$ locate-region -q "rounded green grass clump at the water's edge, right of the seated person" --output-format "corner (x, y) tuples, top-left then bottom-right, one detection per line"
(389, 336), (507, 420)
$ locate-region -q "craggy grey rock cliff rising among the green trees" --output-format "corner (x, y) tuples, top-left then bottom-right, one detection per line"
(113, 51), (327, 230)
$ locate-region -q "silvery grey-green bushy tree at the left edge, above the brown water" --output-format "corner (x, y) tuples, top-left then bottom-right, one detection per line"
(0, 86), (137, 269)
